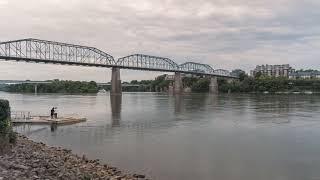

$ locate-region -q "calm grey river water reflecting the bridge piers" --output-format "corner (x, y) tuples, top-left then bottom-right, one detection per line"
(0, 92), (320, 180)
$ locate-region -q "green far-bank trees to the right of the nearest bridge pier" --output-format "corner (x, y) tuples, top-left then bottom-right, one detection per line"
(124, 70), (320, 93)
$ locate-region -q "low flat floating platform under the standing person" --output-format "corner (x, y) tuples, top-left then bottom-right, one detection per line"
(11, 116), (87, 125)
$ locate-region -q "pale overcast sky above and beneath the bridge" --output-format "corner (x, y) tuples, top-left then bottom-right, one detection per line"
(0, 0), (320, 82)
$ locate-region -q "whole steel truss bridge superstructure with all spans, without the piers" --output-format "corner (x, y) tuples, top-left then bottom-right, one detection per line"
(0, 38), (237, 78)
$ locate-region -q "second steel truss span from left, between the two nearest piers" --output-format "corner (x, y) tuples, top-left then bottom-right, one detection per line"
(117, 54), (179, 71)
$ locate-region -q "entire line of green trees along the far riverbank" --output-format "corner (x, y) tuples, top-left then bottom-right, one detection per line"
(3, 70), (320, 93)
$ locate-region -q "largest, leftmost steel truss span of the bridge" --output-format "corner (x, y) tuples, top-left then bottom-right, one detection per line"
(0, 38), (116, 67)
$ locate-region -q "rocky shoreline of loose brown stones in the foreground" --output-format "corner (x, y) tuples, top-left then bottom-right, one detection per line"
(0, 135), (146, 180)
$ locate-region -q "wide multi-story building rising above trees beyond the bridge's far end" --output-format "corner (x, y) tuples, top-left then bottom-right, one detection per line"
(250, 64), (295, 77)
